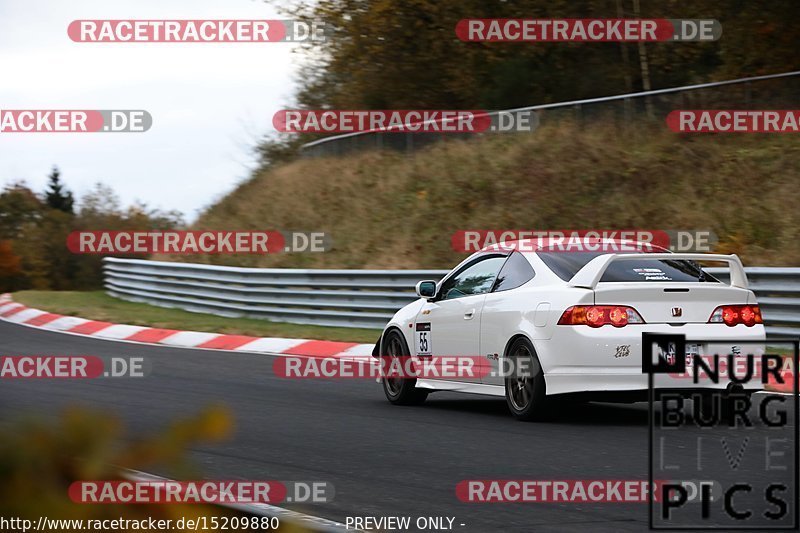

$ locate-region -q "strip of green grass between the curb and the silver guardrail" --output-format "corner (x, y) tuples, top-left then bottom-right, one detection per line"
(13, 291), (380, 343)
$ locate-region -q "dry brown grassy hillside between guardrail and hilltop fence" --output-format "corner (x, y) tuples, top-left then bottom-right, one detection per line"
(183, 123), (800, 268)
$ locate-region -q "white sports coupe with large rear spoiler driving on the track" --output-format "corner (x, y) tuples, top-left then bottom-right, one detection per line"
(373, 239), (765, 420)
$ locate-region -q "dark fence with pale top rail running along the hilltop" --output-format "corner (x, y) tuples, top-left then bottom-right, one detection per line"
(300, 71), (800, 157)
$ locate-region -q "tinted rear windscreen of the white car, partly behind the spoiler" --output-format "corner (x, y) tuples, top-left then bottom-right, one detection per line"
(536, 251), (719, 283)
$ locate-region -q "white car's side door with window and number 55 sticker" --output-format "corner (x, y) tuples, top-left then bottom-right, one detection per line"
(413, 253), (505, 382)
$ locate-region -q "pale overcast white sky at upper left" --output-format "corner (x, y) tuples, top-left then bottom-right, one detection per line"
(0, 0), (301, 220)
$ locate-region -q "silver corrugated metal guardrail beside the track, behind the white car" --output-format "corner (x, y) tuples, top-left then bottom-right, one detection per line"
(104, 258), (800, 337)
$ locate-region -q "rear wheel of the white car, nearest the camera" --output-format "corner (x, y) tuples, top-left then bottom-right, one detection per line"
(505, 337), (549, 421)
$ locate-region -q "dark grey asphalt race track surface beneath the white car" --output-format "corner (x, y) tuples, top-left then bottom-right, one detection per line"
(0, 322), (792, 532)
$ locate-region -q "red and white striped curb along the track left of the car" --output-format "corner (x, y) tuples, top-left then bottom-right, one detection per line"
(0, 294), (375, 359)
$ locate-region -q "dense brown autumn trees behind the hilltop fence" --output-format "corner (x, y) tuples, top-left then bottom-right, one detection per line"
(267, 0), (800, 118)
